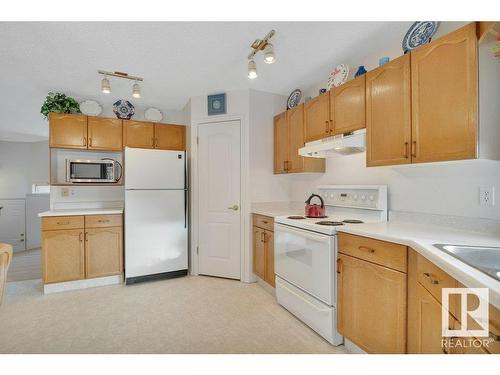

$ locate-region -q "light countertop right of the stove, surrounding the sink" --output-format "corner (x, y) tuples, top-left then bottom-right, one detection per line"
(337, 221), (500, 308)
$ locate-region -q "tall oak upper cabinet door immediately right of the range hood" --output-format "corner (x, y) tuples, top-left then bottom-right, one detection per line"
(366, 54), (411, 167)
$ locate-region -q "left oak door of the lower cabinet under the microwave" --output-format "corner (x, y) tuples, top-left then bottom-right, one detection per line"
(42, 229), (85, 284)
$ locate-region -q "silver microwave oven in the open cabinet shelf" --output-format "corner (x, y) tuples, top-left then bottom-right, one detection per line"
(66, 159), (122, 183)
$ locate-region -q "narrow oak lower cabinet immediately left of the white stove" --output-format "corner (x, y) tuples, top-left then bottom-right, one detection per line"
(252, 214), (275, 287)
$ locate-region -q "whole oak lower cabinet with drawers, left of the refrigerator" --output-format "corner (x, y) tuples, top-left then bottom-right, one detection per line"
(42, 215), (123, 284)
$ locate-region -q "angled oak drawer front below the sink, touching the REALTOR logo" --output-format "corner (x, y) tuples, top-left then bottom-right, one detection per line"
(417, 255), (457, 306)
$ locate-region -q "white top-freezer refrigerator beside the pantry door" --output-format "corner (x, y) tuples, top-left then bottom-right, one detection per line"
(124, 148), (188, 284)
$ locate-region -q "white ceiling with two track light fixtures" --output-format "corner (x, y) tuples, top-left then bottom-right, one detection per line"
(0, 22), (410, 141)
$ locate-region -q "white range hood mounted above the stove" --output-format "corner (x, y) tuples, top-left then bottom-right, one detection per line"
(299, 129), (366, 159)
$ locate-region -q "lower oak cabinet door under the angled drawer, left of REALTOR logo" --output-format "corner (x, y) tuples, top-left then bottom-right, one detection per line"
(408, 283), (446, 354)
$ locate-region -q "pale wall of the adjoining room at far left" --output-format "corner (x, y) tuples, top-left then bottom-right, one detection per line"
(0, 141), (49, 199)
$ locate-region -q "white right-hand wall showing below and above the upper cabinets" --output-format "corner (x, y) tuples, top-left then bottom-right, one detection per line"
(282, 22), (500, 220)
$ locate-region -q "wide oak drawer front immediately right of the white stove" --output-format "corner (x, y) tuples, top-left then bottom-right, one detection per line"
(338, 233), (407, 273)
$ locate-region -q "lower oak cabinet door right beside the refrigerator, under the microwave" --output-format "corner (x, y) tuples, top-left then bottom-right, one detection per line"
(85, 227), (123, 279)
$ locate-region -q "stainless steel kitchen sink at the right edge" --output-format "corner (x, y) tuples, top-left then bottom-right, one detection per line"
(434, 244), (500, 281)
